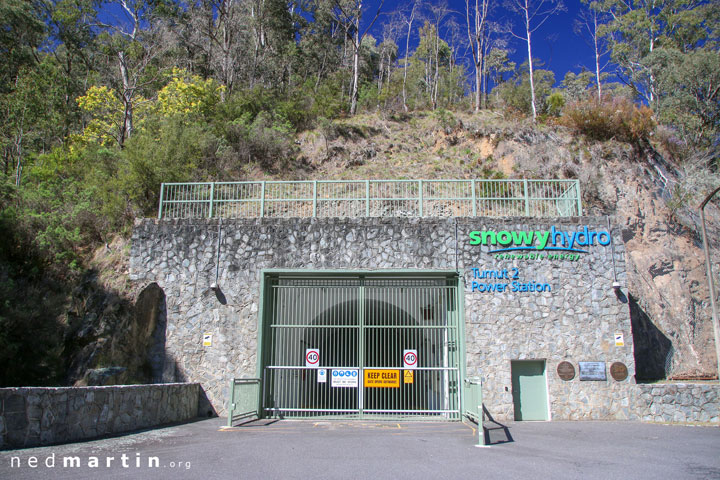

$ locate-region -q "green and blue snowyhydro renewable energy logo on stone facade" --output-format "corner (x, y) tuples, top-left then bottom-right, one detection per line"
(469, 226), (610, 253)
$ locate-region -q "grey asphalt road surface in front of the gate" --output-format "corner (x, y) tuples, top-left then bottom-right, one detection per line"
(0, 418), (720, 480)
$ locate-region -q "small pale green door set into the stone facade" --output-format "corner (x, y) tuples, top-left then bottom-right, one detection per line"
(510, 360), (548, 420)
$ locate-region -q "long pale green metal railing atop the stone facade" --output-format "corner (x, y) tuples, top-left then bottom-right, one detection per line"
(158, 180), (582, 218)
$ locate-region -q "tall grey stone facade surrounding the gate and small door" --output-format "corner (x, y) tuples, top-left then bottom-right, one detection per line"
(130, 217), (635, 420)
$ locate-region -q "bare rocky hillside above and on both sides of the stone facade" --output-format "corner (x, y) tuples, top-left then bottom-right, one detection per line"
(66, 111), (720, 383)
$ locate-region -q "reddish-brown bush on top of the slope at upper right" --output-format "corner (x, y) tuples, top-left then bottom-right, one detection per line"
(560, 97), (655, 145)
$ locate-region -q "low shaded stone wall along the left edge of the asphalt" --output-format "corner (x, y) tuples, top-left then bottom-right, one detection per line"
(0, 383), (200, 449)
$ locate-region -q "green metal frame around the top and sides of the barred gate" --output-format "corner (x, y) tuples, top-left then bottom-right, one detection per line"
(256, 268), (467, 421)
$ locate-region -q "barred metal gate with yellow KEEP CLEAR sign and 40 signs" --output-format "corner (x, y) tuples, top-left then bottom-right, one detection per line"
(263, 275), (461, 420)
